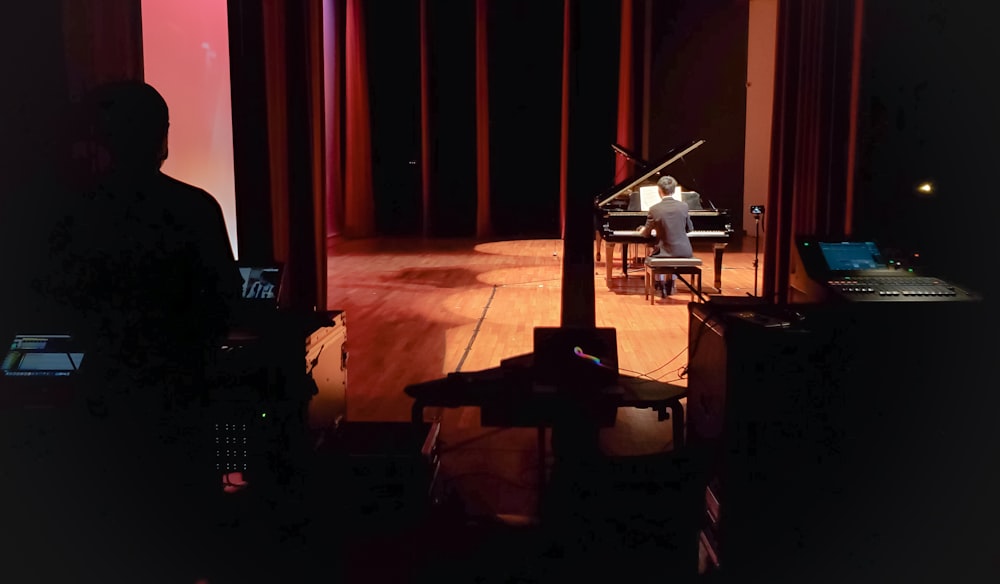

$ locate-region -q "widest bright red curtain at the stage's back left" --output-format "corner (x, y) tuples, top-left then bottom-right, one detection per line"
(344, 0), (375, 237)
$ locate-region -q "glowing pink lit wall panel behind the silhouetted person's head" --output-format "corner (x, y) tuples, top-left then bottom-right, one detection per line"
(142, 0), (239, 254)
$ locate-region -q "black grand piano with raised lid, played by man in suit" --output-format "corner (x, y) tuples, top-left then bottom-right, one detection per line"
(594, 140), (733, 293)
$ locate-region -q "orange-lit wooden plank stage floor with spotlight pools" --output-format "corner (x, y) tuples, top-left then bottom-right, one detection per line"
(327, 238), (759, 516)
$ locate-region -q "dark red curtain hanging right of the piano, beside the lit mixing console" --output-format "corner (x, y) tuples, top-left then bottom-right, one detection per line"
(763, 0), (863, 302)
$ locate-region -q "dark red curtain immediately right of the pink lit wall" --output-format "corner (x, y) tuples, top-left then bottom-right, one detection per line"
(236, 0), (327, 310)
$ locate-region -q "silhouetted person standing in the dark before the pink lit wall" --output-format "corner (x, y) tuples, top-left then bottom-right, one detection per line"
(23, 82), (242, 581)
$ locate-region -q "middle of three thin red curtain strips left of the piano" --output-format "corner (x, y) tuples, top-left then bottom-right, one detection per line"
(476, 0), (493, 238)
